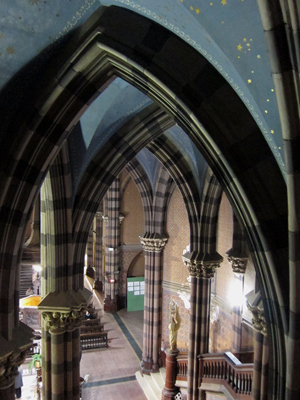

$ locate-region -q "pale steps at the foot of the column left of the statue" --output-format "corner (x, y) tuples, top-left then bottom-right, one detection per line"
(135, 368), (166, 400)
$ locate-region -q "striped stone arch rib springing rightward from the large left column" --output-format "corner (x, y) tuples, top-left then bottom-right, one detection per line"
(73, 104), (174, 280)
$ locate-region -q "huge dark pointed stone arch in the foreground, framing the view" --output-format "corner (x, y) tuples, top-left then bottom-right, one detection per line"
(0, 6), (289, 398)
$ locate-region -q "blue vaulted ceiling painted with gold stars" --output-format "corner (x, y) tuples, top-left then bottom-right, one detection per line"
(0, 0), (285, 188)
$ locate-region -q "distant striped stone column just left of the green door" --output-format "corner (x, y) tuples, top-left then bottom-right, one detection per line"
(104, 178), (120, 313)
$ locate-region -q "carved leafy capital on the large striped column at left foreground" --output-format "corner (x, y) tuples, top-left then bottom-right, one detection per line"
(42, 308), (85, 334)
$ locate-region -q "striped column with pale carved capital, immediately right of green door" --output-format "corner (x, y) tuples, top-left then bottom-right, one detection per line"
(140, 233), (167, 374)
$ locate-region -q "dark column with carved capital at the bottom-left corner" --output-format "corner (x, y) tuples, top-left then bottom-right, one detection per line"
(0, 322), (34, 400)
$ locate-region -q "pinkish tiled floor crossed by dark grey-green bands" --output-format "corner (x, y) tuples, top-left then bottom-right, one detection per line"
(22, 309), (146, 400)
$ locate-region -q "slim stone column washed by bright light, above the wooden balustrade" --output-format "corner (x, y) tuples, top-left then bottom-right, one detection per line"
(227, 253), (248, 352)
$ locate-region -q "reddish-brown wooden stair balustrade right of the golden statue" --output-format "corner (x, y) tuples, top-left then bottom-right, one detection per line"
(176, 352), (253, 400)
